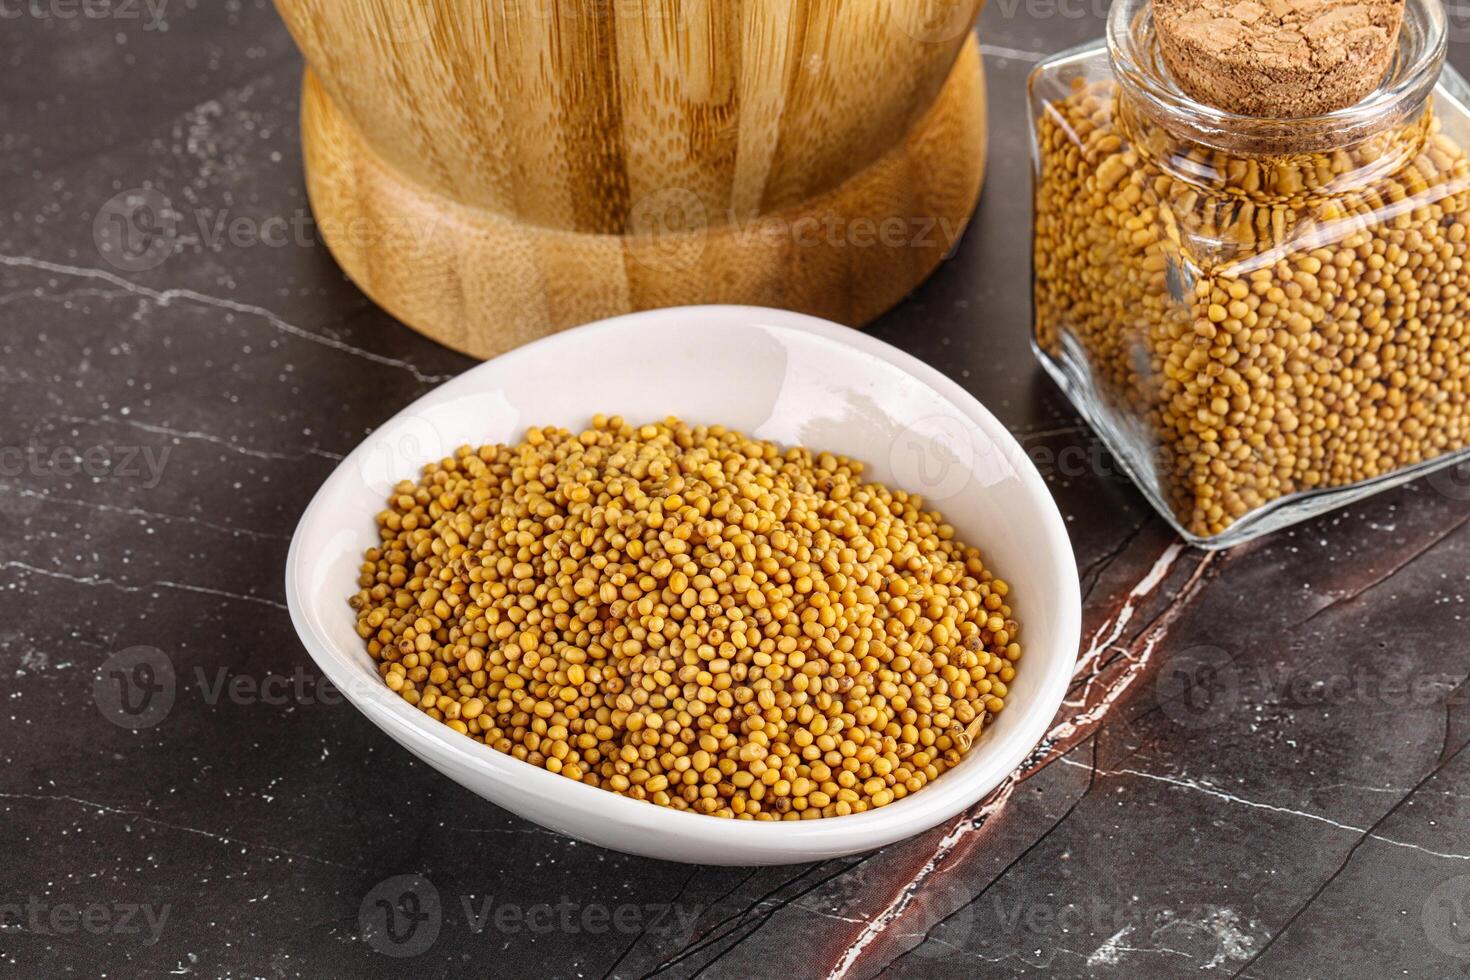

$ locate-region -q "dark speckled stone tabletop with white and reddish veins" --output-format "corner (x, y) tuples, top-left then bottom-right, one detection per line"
(0, 0), (1470, 980)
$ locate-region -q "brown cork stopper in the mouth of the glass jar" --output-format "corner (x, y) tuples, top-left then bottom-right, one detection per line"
(1152, 0), (1404, 119)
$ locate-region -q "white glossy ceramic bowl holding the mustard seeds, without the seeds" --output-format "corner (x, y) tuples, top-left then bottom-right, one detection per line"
(285, 307), (1080, 864)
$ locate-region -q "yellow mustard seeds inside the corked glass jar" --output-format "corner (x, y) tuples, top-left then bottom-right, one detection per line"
(1033, 79), (1470, 538)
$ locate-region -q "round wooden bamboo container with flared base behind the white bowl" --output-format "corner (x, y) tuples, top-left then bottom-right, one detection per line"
(276, 0), (985, 357)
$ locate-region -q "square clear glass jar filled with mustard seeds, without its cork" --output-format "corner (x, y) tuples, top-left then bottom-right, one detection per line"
(1029, 0), (1470, 548)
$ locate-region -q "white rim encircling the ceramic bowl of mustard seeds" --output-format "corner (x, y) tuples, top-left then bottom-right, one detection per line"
(285, 306), (1082, 860)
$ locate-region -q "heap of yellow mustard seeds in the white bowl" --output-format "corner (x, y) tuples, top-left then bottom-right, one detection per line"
(351, 416), (1022, 820)
